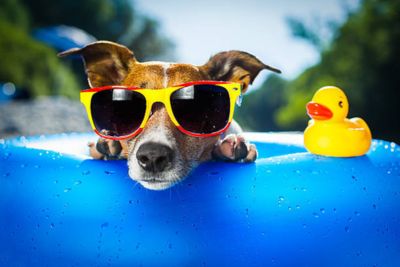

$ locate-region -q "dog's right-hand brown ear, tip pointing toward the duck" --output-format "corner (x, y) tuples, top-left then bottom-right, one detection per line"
(200, 51), (281, 92)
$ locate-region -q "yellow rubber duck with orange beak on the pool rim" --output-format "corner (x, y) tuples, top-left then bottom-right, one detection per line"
(304, 86), (372, 157)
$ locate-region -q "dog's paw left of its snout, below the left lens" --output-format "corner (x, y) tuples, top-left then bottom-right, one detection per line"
(88, 134), (127, 160)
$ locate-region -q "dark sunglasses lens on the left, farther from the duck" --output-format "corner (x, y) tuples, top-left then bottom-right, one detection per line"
(91, 89), (146, 137)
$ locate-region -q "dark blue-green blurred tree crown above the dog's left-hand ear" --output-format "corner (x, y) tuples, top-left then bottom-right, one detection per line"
(22, 0), (173, 60)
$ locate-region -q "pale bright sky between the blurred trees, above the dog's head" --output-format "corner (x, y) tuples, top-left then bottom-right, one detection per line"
(134, 0), (358, 86)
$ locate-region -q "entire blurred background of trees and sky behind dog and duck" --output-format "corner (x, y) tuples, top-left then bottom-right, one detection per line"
(0, 0), (400, 143)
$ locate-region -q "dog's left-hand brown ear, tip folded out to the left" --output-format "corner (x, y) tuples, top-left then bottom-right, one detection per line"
(58, 41), (136, 87)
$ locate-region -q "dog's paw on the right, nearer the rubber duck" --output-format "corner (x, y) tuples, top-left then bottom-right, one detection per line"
(212, 134), (257, 162)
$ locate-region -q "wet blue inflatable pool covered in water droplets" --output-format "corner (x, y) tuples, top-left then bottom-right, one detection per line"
(0, 134), (400, 266)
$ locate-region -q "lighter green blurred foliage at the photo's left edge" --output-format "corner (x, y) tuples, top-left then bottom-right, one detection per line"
(0, 0), (79, 98)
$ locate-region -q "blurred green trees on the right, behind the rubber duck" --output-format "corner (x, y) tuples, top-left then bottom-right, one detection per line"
(238, 0), (400, 141)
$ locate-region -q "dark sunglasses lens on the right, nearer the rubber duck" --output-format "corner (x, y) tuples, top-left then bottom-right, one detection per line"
(171, 85), (230, 134)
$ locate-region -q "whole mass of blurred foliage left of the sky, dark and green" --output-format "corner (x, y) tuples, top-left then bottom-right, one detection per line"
(0, 0), (173, 98)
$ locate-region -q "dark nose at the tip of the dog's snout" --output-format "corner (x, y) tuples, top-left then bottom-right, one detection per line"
(136, 142), (174, 172)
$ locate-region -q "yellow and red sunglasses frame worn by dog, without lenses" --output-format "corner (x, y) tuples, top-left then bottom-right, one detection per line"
(80, 81), (242, 140)
